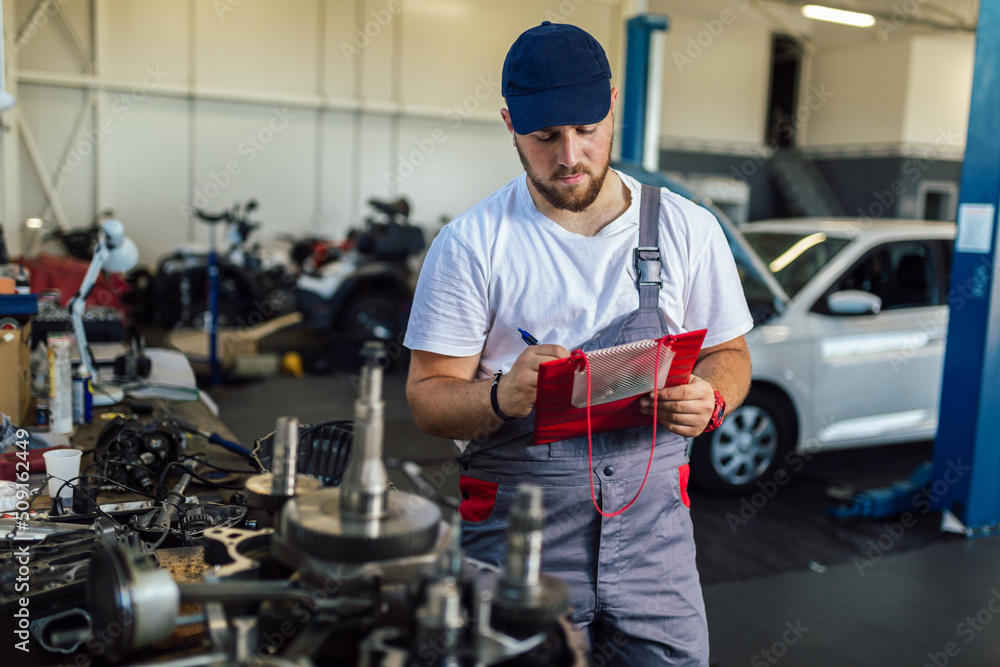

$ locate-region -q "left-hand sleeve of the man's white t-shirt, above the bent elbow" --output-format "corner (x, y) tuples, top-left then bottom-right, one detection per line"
(403, 226), (490, 357)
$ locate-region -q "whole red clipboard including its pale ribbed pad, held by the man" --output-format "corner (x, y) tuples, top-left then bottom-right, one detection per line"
(534, 329), (706, 445)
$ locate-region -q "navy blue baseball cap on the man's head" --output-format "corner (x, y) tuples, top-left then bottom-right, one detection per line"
(500, 21), (611, 134)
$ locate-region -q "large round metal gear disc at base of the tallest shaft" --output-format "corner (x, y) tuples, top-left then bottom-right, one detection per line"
(281, 489), (441, 563)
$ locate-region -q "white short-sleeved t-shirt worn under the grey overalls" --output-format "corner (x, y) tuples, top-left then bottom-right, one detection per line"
(404, 172), (753, 378)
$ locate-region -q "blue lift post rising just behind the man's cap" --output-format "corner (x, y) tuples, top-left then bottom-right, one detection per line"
(622, 14), (667, 164)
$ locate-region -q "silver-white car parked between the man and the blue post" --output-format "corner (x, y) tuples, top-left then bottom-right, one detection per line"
(691, 218), (956, 493)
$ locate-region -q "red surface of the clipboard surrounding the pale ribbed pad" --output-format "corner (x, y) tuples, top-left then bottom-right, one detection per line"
(534, 329), (708, 445)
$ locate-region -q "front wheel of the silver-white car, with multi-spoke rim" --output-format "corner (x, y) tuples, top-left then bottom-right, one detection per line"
(691, 389), (794, 494)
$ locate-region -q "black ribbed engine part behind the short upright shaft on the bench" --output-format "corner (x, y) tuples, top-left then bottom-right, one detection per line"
(251, 421), (354, 486)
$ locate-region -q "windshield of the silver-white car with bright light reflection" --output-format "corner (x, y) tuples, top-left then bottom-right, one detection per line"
(743, 228), (851, 297)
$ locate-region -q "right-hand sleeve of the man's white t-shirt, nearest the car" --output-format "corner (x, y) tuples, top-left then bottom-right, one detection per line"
(684, 209), (753, 347)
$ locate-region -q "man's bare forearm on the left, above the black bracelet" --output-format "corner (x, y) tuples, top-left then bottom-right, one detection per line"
(407, 377), (501, 440)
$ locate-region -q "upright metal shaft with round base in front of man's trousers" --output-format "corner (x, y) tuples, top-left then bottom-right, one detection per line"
(493, 484), (569, 638)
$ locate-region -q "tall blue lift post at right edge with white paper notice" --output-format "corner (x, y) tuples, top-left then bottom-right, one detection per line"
(929, 0), (1000, 535)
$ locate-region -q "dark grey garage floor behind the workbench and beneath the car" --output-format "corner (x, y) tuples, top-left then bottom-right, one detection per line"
(210, 372), (1000, 667)
